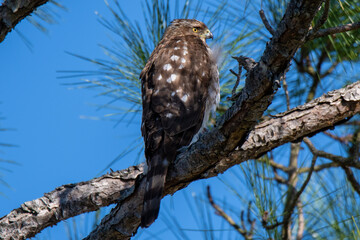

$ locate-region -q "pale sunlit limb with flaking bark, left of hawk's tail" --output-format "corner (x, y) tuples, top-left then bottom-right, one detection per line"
(0, 166), (143, 239)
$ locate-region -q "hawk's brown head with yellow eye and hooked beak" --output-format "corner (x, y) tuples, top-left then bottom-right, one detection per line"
(163, 19), (213, 42)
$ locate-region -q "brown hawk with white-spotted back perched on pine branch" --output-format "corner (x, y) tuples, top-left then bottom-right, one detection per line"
(140, 19), (220, 227)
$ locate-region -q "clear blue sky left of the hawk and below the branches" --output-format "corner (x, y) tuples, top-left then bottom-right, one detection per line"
(0, 0), (232, 239)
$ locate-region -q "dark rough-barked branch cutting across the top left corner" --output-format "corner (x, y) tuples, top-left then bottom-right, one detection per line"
(0, 0), (49, 43)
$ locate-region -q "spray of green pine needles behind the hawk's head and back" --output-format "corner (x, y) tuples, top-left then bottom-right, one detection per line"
(66, 0), (258, 116)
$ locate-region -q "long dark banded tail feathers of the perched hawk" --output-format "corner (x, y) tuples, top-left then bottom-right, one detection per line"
(141, 155), (169, 228)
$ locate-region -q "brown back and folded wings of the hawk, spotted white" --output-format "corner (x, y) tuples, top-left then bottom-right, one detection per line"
(141, 36), (211, 156)
